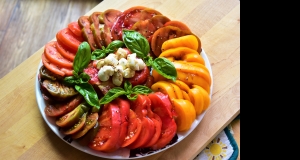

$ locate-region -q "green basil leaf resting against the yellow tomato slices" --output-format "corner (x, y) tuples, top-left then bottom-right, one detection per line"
(152, 57), (177, 81)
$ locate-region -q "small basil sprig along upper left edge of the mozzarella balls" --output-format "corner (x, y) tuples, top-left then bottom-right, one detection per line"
(91, 40), (124, 60)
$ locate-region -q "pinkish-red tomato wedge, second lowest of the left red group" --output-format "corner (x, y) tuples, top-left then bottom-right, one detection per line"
(44, 41), (73, 69)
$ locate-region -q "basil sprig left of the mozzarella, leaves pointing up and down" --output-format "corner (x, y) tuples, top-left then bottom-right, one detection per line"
(64, 42), (100, 111)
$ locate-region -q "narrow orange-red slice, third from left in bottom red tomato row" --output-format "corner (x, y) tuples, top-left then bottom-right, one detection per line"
(121, 109), (142, 147)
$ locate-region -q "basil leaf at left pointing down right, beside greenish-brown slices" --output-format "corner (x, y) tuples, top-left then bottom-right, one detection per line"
(75, 83), (100, 109)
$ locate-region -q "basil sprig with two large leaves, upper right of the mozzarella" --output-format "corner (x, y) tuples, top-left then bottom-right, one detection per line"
(122, 29), (177, 81)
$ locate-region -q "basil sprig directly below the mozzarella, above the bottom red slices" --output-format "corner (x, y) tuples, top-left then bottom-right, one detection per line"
(99, 81), (153, 104)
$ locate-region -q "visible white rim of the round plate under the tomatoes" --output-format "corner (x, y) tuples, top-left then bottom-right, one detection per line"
(35, 49), (213, 159)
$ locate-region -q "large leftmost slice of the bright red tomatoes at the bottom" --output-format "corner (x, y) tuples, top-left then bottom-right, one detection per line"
(88, 103), (121, 152)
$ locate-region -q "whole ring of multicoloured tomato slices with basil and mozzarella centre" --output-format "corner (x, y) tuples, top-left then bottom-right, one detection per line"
(39, 6), (211, 153)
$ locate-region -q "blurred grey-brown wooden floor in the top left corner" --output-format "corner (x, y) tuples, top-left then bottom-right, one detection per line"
(0, 0), (102, 79)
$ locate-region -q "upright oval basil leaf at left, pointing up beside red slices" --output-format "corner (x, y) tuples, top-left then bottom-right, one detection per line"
(73, 41), (91, 73)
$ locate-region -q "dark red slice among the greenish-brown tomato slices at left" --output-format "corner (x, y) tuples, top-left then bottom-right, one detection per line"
(45, 95), (83, 117)
